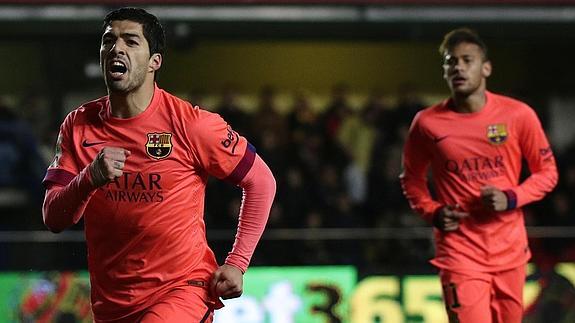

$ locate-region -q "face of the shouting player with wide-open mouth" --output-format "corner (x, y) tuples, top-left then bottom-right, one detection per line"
(100, 20), (162, 93)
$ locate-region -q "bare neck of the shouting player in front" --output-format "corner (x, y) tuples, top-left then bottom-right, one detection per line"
(108, 82), (154, 118)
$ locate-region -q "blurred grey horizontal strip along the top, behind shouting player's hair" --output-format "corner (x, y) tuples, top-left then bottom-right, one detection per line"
(0, 5), (575, 23)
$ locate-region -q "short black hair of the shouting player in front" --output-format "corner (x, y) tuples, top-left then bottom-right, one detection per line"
(102, 7), (166, 56)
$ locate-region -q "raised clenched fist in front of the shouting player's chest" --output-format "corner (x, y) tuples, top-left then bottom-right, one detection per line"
(90, 147), (131, 187)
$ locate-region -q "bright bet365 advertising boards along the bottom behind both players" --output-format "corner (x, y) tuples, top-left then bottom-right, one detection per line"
(0, 263), (575, 323)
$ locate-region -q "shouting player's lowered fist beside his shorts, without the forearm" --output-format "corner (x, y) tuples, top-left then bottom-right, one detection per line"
(210, 264), (244, 299)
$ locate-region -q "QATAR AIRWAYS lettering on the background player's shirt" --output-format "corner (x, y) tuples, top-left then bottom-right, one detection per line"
(444, 155), (506, 182)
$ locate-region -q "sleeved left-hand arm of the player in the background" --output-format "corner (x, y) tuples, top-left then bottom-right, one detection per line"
(399, 114), (443, 223)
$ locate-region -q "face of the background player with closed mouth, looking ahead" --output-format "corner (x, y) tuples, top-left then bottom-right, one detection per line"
(443, 42), (491, 97)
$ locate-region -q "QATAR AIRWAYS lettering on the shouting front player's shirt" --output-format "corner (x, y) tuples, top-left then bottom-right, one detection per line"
(104, 172), (164, 203)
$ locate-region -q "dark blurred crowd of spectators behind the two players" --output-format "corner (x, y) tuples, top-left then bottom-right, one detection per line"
(0, 83), (575, 268)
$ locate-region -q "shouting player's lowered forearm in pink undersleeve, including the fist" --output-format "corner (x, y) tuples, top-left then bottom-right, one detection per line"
(211, 154), (276, 299)
